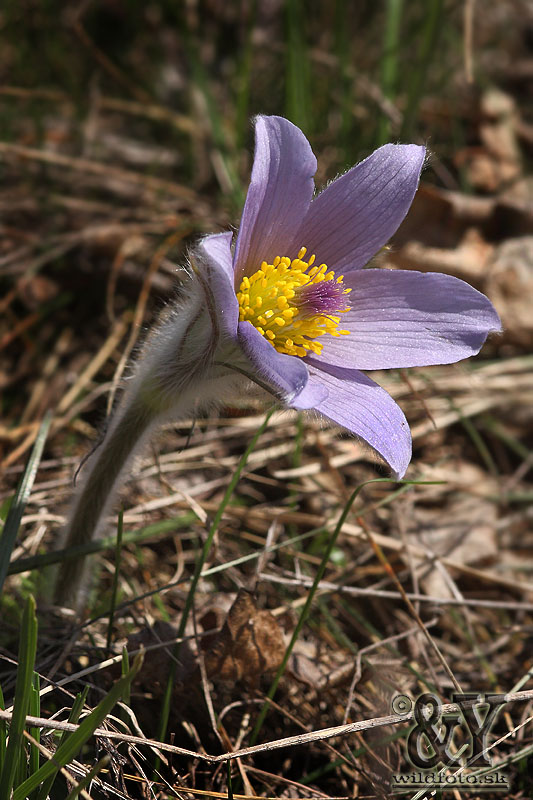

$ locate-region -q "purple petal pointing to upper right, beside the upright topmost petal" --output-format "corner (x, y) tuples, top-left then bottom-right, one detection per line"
(294, 144), (426, 273)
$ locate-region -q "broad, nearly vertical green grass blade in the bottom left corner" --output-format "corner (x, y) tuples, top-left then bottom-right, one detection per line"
(0, 595), (37, 800)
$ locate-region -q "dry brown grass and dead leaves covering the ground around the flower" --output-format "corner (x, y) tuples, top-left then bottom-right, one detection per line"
(0, 2), (533, 798)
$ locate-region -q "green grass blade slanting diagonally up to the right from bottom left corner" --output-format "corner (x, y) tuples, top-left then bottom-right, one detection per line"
(13, 654), (143, 800)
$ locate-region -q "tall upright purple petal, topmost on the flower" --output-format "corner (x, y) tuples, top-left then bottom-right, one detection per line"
(235, 117), (316, 285)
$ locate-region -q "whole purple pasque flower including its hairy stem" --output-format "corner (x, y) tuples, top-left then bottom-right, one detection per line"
(56, 117), (500, 602)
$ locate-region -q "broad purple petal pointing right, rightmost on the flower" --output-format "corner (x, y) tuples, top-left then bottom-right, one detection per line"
(318, 269), (501, 369)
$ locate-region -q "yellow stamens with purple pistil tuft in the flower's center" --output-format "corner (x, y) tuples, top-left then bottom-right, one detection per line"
(237, 247), (351, 357)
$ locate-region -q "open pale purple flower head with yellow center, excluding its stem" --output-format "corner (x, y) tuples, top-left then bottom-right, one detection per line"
(193, 117), (500, 477)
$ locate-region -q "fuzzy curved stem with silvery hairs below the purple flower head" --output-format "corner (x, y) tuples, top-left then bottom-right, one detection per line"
(54, 284), (235, 609)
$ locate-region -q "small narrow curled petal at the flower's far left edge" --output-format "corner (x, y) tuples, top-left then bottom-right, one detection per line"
(191, 232), (239, 339)
